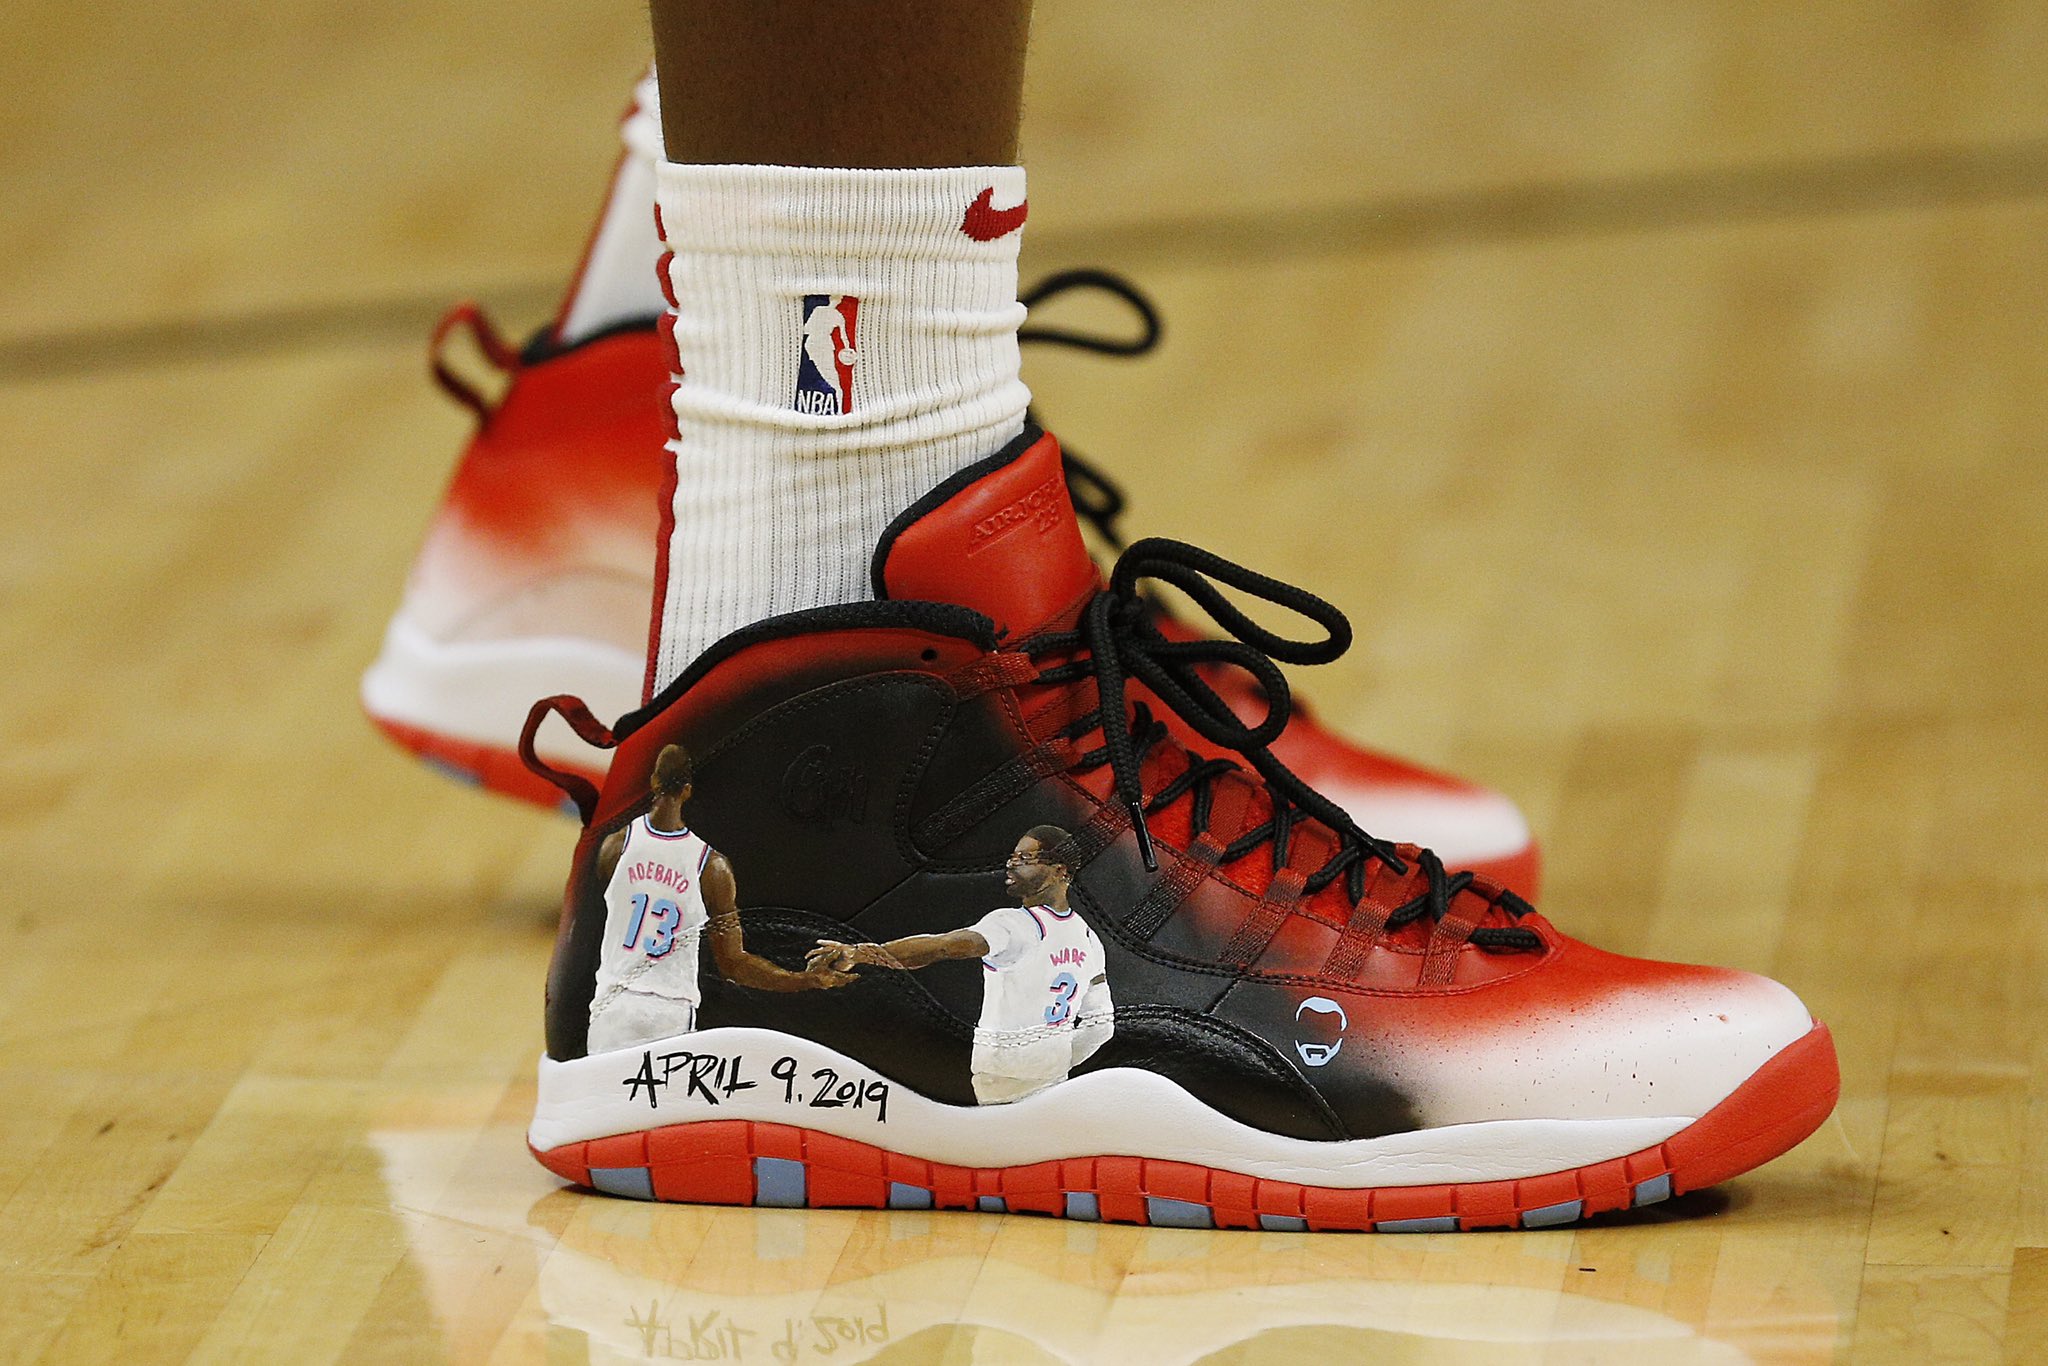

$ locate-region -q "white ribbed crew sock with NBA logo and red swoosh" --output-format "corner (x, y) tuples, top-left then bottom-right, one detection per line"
(651, 162), (1030, 690)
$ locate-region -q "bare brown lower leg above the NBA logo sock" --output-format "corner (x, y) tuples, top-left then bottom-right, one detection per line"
(649, 0), (1030, 168)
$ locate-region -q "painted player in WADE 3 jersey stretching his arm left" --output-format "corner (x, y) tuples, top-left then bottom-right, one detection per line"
(805, 825), (1114, 1106)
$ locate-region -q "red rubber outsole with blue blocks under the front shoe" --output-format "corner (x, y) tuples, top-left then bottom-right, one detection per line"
(535, 1024), (1841, 1233)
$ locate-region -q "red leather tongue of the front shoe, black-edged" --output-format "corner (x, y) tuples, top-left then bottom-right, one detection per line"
(874, 424), (1100, 639)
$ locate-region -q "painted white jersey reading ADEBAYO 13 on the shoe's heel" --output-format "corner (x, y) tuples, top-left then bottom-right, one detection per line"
(590, 815), (711, 1053)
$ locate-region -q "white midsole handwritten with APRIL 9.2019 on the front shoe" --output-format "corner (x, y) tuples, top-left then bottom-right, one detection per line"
(526, 1028), (1694, 1190)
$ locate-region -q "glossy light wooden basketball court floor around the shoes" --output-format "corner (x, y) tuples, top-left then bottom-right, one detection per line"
(0, 0), (2048, 1364)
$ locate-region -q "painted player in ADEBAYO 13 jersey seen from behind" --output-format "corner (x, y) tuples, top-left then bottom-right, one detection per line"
(590, 745), (854, 1053)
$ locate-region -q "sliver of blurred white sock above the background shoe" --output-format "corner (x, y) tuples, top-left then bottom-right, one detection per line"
(555, 70), (668, 346)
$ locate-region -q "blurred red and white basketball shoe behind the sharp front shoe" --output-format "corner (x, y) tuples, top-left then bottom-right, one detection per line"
(362, 280), (1540, 895)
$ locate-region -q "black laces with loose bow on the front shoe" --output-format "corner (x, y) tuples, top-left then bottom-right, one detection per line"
(1024, 537), (1542, 950)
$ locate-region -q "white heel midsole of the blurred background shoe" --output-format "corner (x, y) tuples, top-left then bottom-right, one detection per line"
(362, 612), (641, 768)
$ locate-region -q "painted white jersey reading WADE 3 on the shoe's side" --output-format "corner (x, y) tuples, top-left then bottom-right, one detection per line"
(973, 905), (1112, 1104)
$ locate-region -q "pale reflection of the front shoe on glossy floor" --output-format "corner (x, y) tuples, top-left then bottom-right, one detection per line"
(371, 1124), (1841, 1366)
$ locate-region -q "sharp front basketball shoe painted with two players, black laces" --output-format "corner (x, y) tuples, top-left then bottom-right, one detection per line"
(524, 428), (1837, 1231)
